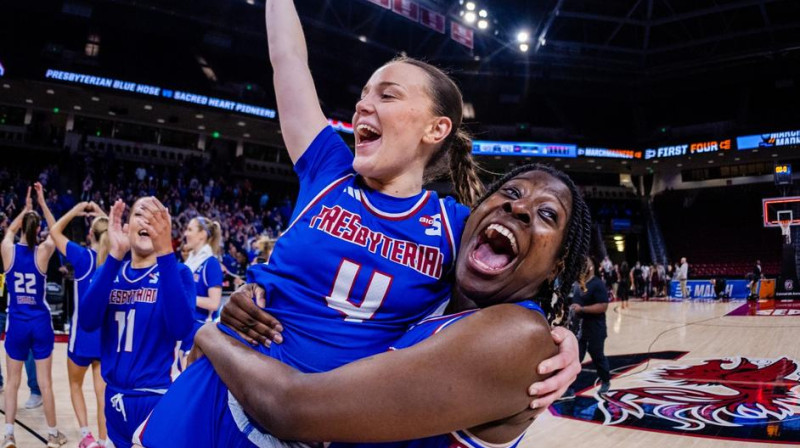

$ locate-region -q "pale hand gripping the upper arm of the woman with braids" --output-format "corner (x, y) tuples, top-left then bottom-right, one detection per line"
(528, 327), (581, 409)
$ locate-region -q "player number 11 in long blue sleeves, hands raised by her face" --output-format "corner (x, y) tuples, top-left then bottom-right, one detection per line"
(78, 197), (196, 448)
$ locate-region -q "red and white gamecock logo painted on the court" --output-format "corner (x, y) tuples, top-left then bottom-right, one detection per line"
(598, 358), (800, 430)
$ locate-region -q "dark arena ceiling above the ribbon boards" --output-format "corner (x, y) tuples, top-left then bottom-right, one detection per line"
(0, 0), (800, 158)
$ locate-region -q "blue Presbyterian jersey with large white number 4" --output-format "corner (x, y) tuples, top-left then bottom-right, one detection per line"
(248, 127), (469, 372)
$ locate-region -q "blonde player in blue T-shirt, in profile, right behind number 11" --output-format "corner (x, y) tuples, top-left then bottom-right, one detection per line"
(181, 216), (222, 367)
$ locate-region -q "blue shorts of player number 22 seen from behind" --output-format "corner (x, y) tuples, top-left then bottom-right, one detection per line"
(6, 314), (55, 362)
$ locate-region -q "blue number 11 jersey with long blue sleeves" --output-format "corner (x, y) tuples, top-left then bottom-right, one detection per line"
(78, 254), (196, 391)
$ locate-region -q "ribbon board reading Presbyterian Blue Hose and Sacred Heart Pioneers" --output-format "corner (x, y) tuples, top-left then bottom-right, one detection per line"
(44, 69), (277, 119)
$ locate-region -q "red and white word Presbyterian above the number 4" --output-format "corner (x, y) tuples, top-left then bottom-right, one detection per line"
(309, 205), (444, 279)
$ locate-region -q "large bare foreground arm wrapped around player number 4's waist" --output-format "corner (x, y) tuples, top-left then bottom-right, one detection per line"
(200, 305), (556, 442)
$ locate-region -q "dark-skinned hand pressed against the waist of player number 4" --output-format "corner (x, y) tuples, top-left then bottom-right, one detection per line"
(220, 283), (283, 346)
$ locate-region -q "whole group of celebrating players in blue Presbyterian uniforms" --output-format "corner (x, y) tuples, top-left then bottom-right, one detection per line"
(2, 0), (590, 448)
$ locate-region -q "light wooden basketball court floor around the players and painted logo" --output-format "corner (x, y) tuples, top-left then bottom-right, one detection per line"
(0, 301), (800, 448)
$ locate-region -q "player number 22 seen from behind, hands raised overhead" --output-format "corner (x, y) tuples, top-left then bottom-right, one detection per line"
(1, 186), (67, 448)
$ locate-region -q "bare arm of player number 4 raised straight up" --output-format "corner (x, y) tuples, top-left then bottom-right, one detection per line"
(266, 0), (328, 163)
